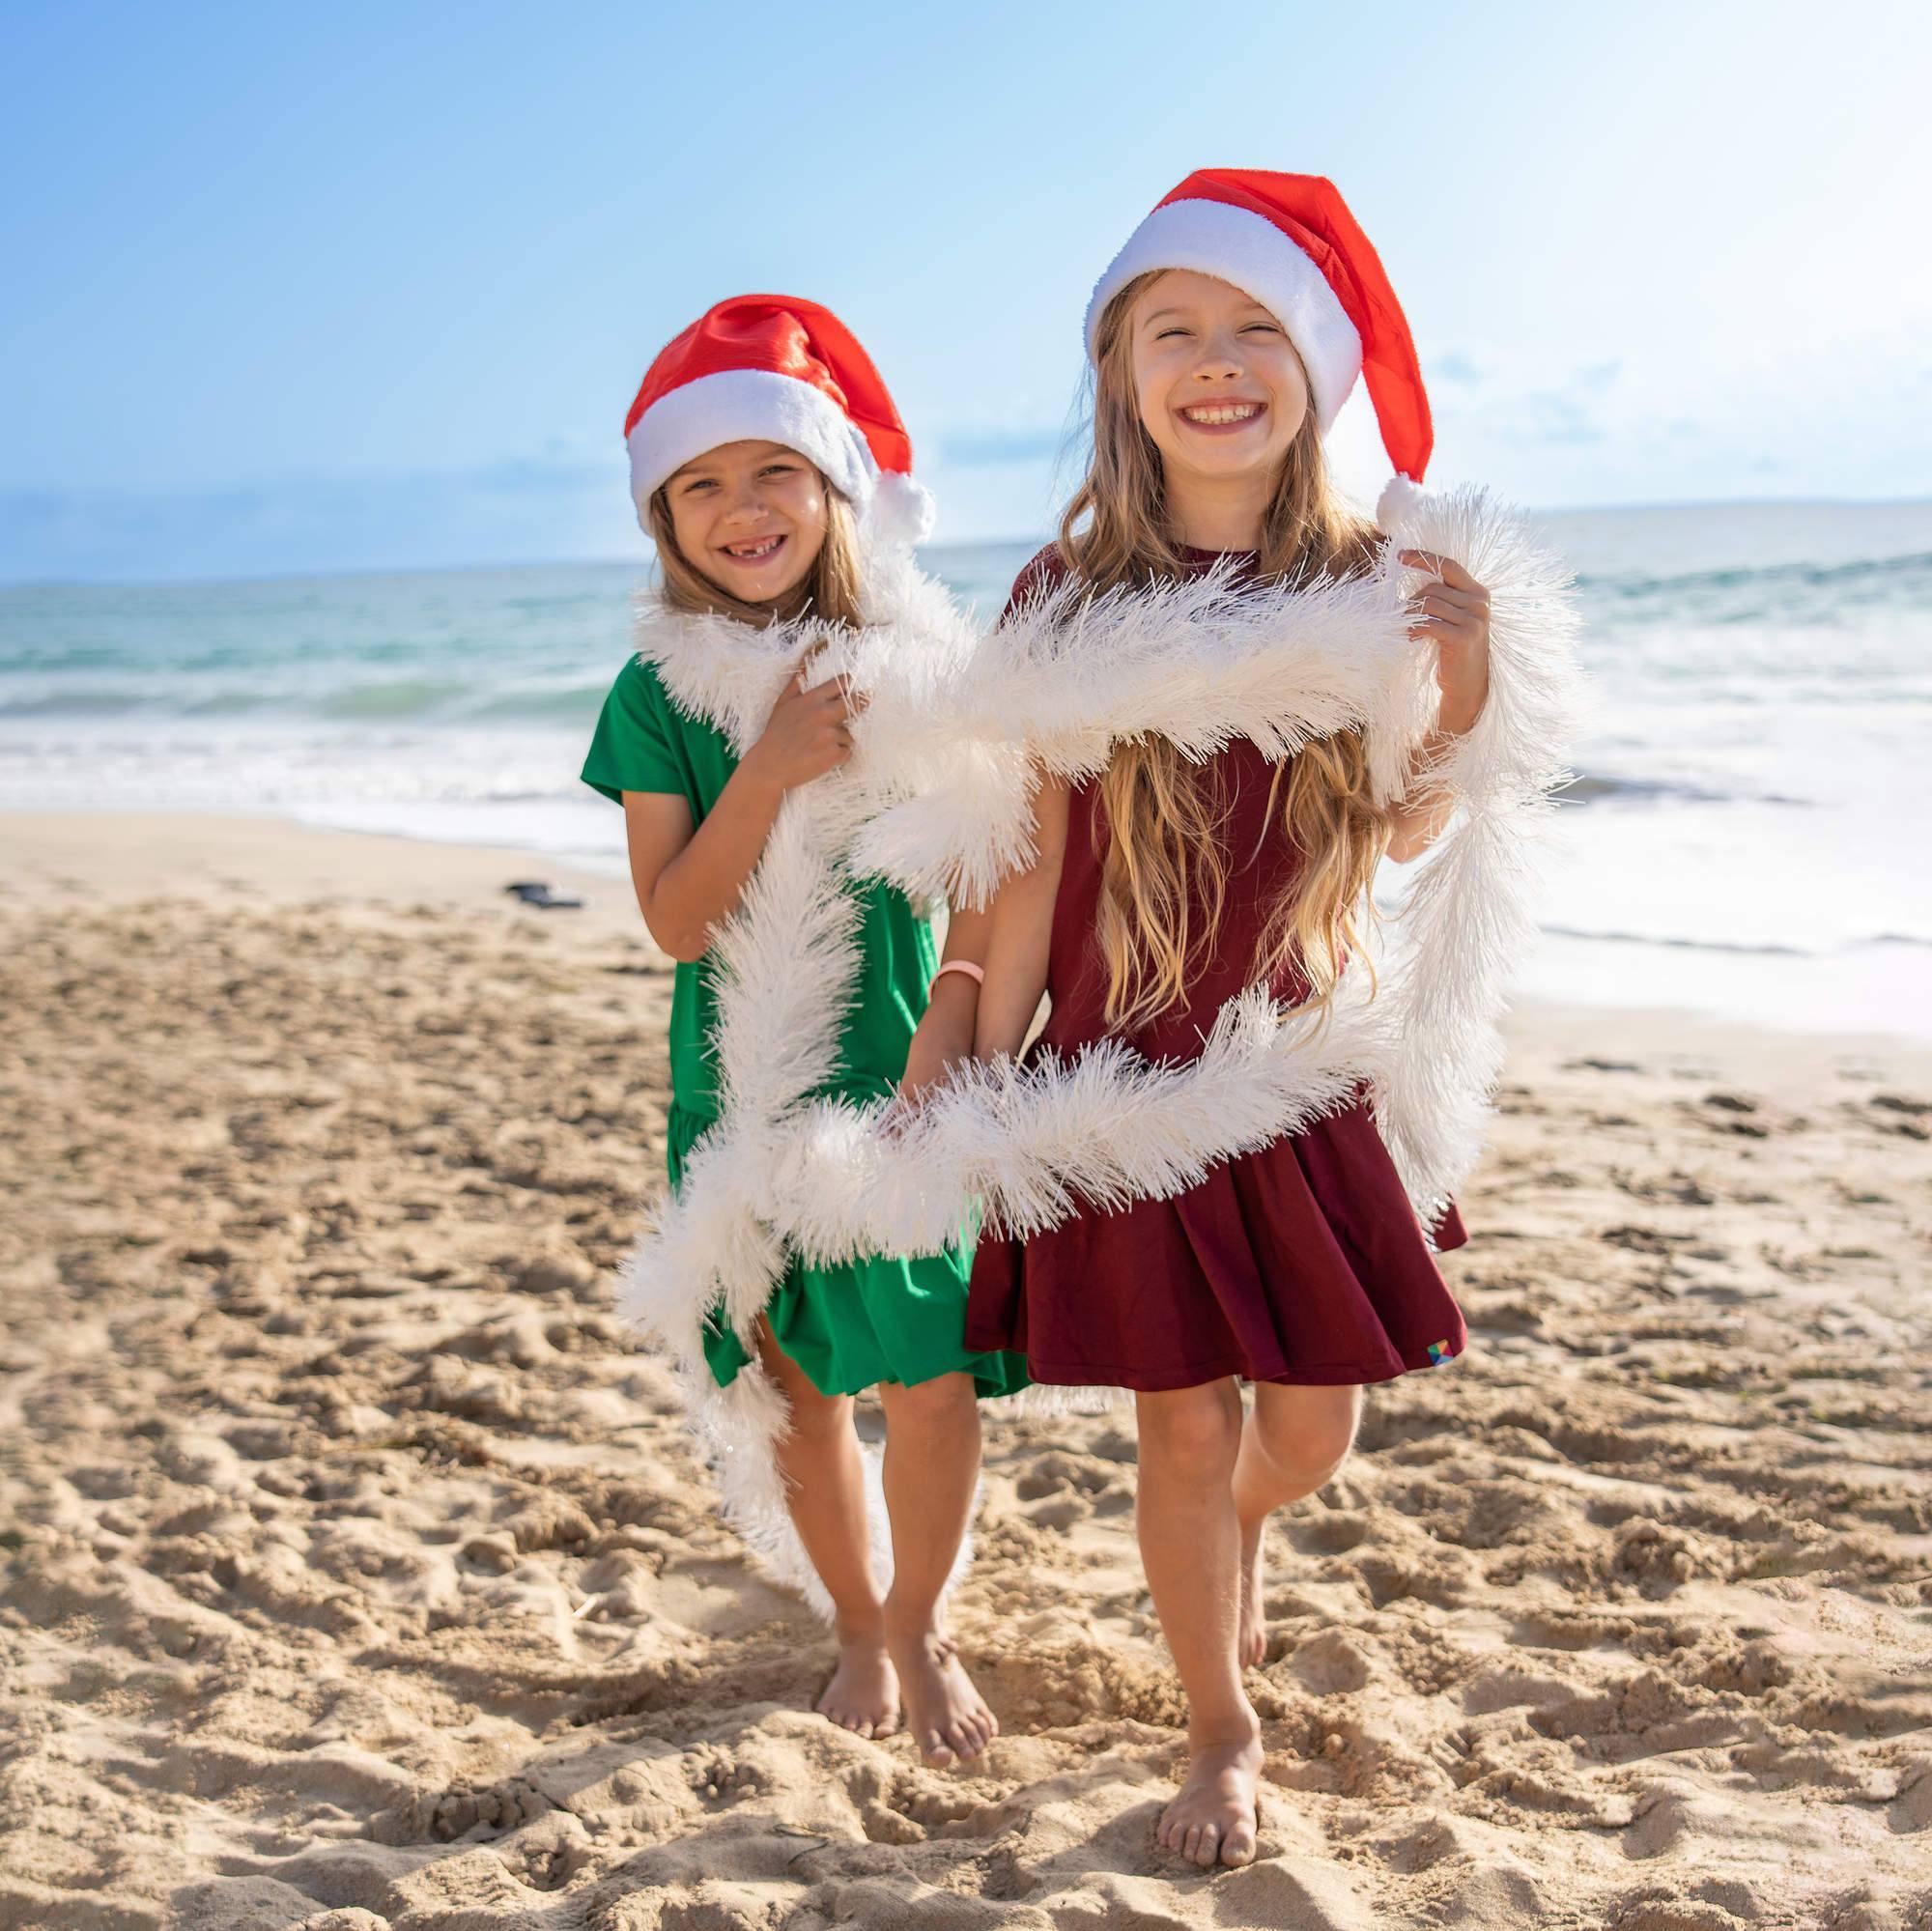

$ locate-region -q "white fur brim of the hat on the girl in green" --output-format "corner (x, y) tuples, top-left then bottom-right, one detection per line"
(624, 369), (879, 529)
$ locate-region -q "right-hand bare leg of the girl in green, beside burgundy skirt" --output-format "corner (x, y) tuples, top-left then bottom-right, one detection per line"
(879, 1373), (999, 1769)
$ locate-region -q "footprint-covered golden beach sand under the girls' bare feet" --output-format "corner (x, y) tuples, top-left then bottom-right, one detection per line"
(0, 817), (1932, 1931)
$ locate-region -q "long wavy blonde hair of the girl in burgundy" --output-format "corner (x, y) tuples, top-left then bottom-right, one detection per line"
(1059, 270), (1391, 1031)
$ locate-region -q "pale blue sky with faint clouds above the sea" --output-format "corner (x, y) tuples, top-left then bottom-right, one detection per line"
(0, 0), (1932, 580)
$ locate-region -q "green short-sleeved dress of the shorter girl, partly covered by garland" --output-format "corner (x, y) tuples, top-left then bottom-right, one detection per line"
(583, 659), (1026, 1394)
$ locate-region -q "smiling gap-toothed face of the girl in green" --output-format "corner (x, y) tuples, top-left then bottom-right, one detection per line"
(665, 442), (825, 605)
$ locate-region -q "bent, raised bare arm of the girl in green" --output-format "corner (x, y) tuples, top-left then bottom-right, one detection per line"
(624, 676), (858, 961)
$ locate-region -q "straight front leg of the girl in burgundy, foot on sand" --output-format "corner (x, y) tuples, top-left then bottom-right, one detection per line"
(1138, 1380), (1262, 1865)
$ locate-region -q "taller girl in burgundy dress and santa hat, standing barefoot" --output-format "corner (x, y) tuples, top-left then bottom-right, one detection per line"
(966, 170), (1490, 1865)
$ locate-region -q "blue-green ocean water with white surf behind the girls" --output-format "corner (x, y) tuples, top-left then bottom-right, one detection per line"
(0, 504), (1932, 1036)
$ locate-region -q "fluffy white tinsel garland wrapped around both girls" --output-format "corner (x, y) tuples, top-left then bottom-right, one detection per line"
(624, 485), (1575, 1610)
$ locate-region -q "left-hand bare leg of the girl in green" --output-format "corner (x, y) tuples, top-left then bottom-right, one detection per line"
(757, 1319), (898, 1736)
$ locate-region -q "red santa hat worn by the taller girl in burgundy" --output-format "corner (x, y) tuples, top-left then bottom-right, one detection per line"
(1086, 168), (1435, 483)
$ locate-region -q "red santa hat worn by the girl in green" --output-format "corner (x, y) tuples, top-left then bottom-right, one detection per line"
(624, 296), (933, 543)
